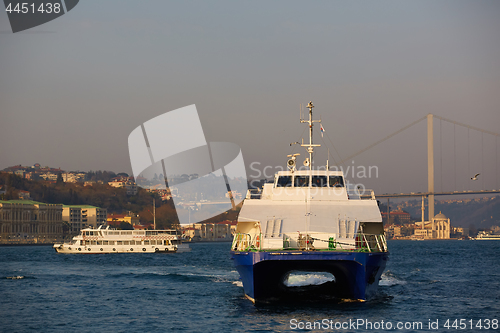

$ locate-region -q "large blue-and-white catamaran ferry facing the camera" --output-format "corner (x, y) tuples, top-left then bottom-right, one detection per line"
(231, 102), (389, 303)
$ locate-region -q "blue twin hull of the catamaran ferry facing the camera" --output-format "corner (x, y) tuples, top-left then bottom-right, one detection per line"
(231, 251), (389, 303)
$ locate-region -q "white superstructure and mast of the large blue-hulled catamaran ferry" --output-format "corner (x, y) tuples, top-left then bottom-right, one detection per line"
(232, 102), (387, 252)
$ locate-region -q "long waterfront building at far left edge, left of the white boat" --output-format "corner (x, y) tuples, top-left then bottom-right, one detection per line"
(0, 200), (64, 244)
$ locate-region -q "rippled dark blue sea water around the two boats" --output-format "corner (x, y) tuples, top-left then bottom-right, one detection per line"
(0, 241), (500, 332)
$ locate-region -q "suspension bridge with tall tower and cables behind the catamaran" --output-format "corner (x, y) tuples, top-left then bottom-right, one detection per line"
(330, 114), (500, 221)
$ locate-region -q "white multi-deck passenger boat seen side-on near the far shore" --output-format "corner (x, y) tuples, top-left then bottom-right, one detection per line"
(54, 226), (191, 253)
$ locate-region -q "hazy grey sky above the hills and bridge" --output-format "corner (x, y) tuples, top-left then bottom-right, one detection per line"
(0, 0), (500, 192)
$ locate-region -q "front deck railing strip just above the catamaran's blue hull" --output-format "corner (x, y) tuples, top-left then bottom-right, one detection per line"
(231, 232), (388, 252)
